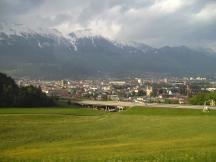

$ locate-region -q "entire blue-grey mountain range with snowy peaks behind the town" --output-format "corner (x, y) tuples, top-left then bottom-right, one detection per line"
(0, 25), (216, 79)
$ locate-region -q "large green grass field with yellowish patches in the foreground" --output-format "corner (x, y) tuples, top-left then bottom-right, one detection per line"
(0, 108), (216, 162)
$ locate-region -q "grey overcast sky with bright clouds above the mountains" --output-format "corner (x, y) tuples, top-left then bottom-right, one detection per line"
(0, 0), (216, 50)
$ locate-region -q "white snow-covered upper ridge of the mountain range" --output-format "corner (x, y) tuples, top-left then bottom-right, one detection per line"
(0, 24), (153, 51)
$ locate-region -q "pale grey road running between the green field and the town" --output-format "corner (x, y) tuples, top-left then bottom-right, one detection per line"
(76, 100), (216, 110)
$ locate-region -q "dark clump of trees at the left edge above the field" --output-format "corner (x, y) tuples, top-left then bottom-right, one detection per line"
(0, 73), (55, 107)
